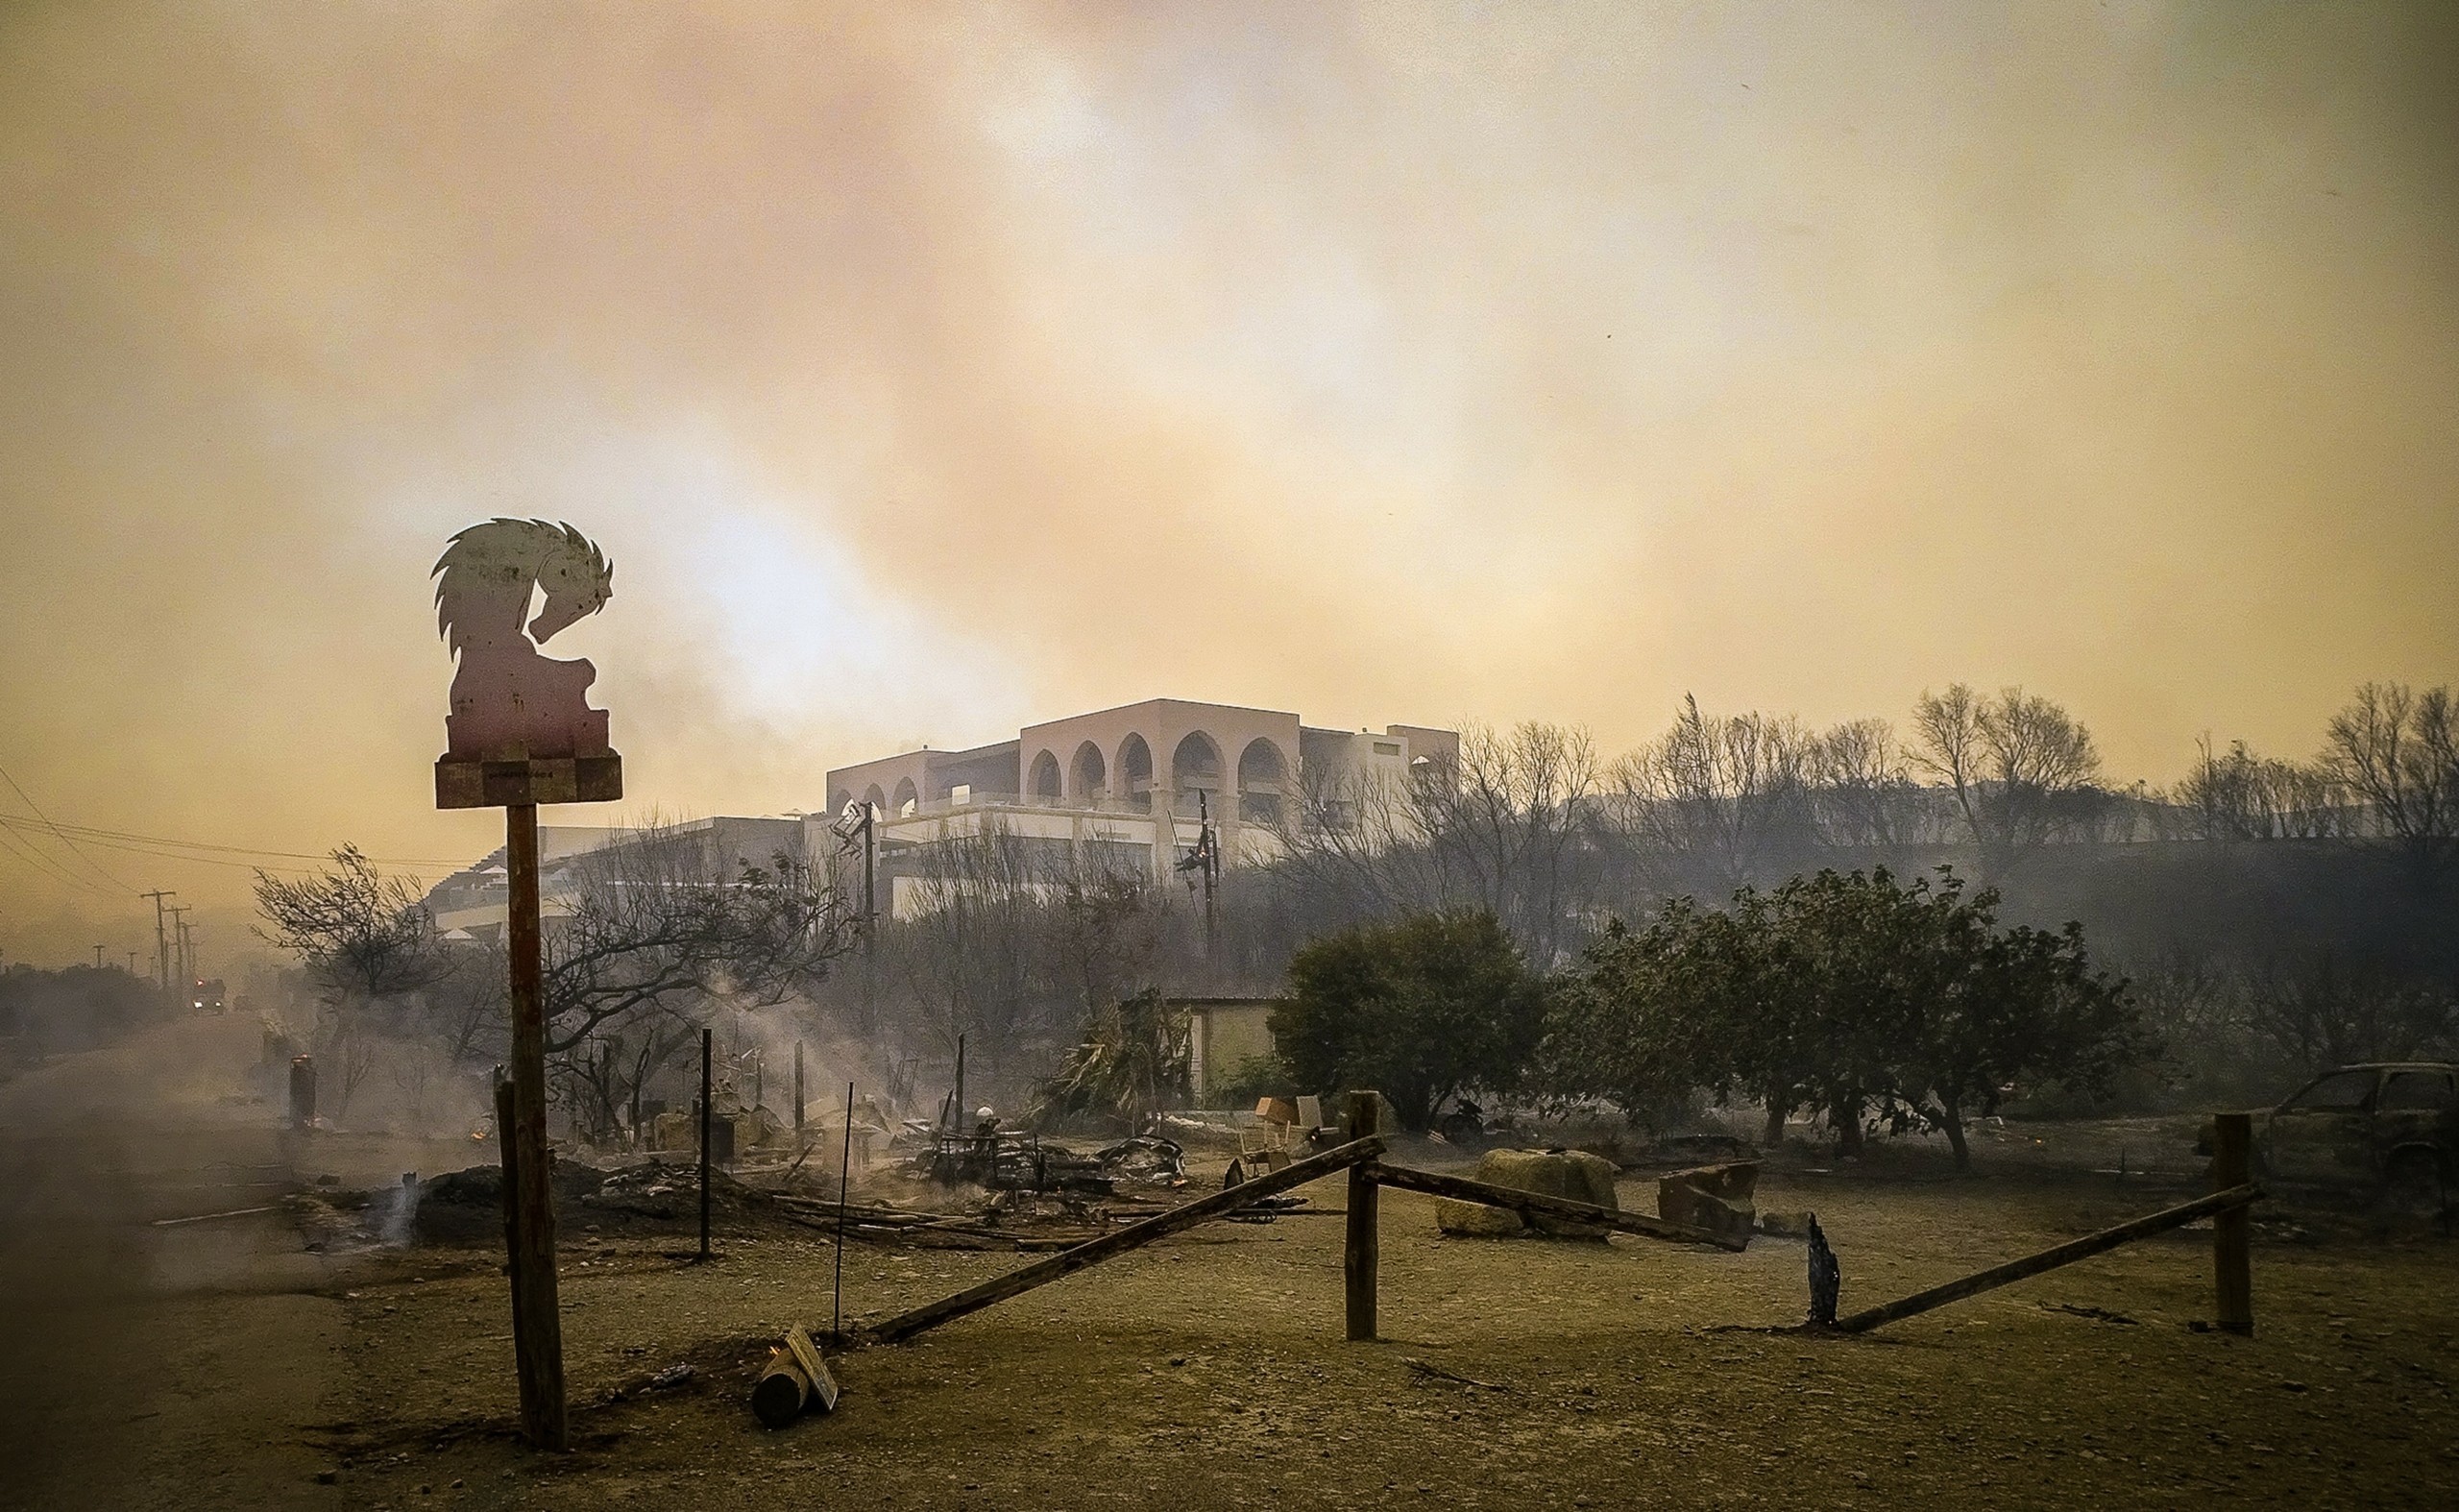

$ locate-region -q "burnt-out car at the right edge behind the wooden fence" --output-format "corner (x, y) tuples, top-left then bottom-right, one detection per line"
(2255, 1060), (2459, 1205)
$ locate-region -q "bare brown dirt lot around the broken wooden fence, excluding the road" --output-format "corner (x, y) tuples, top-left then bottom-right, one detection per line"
(297, 1155), (2459, 1509)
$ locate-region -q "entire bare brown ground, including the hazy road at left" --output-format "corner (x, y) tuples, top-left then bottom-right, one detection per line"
(0, 1025), (2459, 1512)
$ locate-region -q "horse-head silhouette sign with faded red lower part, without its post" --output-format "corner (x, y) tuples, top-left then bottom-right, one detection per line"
(433, 519), (622, 809)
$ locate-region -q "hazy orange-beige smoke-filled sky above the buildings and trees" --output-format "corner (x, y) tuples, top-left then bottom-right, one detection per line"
(0, 0), (2459, 954)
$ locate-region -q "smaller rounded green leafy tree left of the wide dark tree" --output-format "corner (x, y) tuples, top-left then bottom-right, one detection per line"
(1272, 910), (1545, 1131)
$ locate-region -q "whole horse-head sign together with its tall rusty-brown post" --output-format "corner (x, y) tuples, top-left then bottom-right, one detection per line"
(433, 519), (622, 1453)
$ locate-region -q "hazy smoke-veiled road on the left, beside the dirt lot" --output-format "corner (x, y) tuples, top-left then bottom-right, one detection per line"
(0, 1015), (350, 1507)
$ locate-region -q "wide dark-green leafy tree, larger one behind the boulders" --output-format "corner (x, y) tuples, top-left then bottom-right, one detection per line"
(1542, 867), (2155, 1165)
